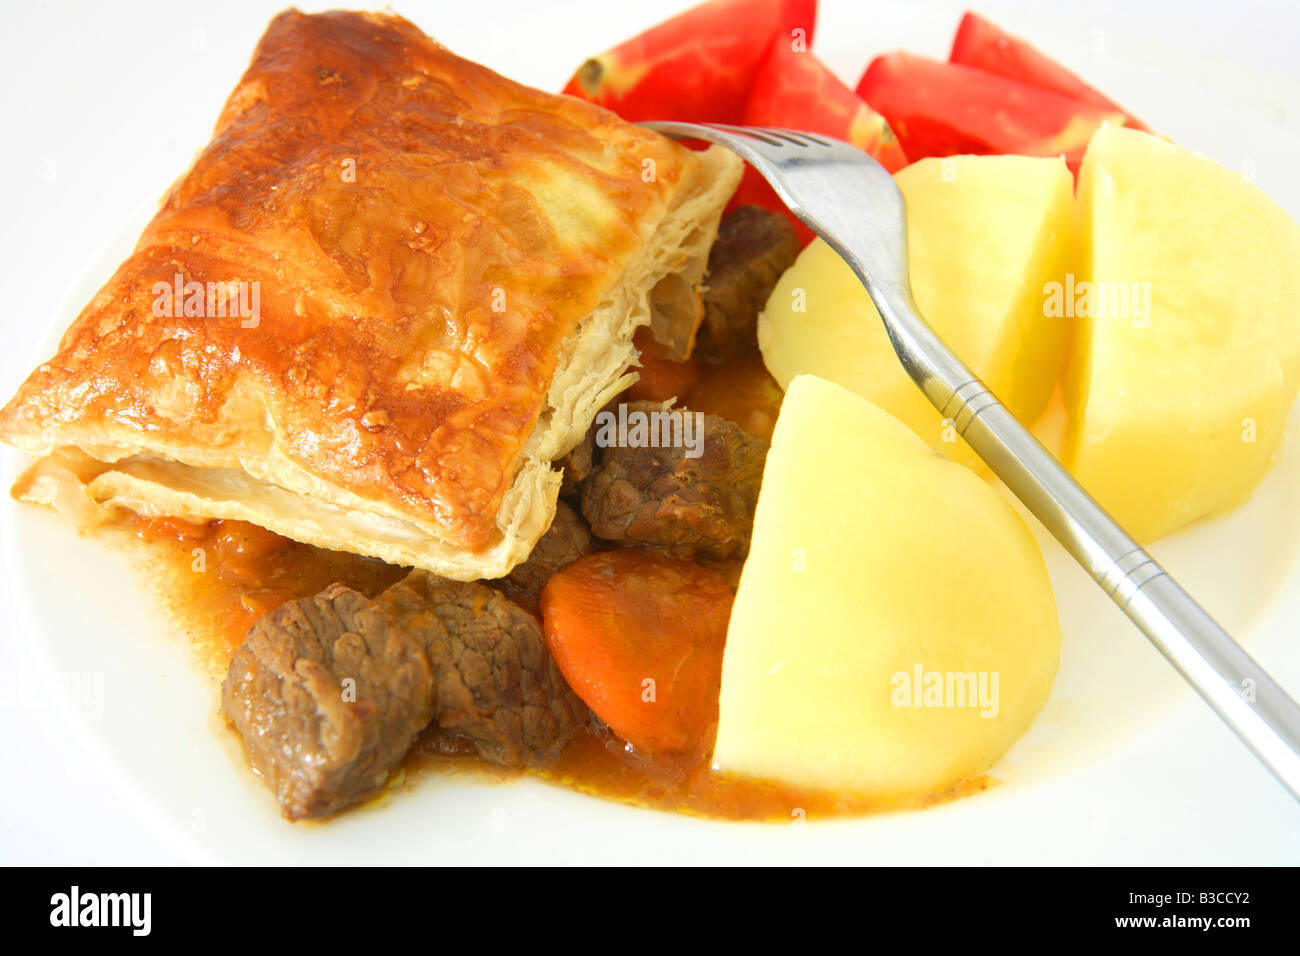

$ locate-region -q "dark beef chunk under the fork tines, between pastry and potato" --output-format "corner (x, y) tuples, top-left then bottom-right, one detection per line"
(696, 206), (800, 360)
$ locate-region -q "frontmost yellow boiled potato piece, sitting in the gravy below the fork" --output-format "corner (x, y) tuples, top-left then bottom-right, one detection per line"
(714, 375), (1061, 799)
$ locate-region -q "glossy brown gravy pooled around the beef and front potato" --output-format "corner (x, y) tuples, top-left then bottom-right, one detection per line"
(122, 359), (989, 822)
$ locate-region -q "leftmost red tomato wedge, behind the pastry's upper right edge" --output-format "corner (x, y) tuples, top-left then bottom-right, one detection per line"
(564, 0), (816, 122)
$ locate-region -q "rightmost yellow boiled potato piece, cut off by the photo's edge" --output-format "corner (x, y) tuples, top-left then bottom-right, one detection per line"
(1063, 129), (1300, 541)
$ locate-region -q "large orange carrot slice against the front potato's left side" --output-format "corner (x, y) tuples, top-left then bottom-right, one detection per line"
(541, 548), (735, 756)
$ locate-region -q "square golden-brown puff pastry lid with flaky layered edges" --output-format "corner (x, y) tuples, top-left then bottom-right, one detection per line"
(0, 10), (740, 579)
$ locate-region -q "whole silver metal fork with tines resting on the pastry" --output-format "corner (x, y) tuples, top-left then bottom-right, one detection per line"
(644, 122), (1300, 799)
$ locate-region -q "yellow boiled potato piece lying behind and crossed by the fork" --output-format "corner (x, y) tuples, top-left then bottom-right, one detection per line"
(758, 156), (1075, 466)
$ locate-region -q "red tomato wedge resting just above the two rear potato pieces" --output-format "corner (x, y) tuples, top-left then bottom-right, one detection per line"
(858, 52), (1125, 172)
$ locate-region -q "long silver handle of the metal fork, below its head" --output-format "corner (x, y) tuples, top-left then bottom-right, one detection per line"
(868, 283), (1300, 800)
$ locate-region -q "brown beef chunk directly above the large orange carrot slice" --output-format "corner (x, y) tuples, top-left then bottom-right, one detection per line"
(582, 402), (767, 558)
